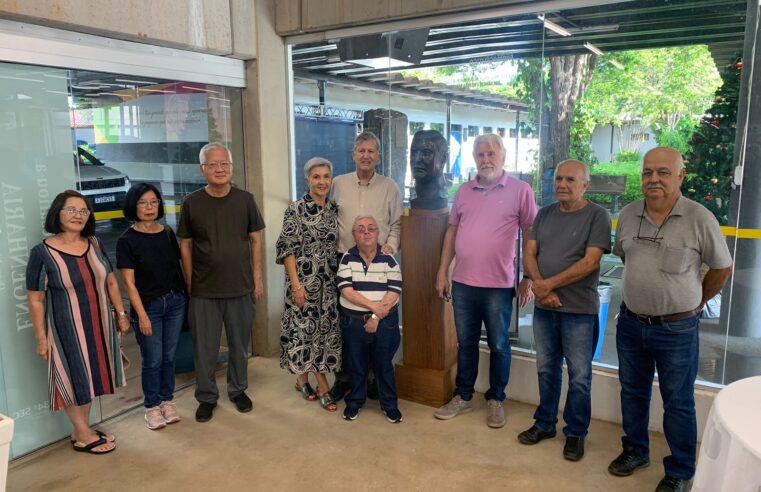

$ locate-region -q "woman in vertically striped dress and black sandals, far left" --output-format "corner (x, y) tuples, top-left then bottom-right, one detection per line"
(26, 190), (129, 454)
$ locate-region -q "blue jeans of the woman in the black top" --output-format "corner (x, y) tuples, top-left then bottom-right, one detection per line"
(132, 292), (186, 408)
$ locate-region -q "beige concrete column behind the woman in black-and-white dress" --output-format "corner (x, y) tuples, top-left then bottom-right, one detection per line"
(243, 0), (290, 355)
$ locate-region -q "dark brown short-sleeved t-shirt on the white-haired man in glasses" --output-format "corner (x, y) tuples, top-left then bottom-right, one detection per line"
(177, 188), (264, 299)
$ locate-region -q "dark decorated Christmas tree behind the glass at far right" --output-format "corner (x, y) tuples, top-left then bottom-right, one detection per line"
(682, 54), (742, 225)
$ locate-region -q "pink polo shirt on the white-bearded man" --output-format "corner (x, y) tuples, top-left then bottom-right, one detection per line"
(449, 172), (537, 288)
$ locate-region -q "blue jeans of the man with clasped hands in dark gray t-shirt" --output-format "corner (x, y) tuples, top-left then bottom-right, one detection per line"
(534, 307), (599, 437)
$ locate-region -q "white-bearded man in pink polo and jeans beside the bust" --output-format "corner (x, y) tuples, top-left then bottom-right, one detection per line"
(434, 134), (537, 428)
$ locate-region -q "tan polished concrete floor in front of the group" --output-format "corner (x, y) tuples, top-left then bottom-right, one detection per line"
(7, 357), (668, 492)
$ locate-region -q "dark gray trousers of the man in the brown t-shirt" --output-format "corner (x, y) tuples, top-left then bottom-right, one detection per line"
(188, 294), (256, 403)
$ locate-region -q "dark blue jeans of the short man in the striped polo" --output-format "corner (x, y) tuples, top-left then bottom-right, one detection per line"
(341, 311), (401, 410)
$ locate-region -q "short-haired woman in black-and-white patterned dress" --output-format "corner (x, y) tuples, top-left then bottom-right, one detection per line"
(276, 157), (341, 412)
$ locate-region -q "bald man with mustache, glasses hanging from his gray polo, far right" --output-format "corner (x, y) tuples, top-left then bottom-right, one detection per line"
(608, 147), (732, 492)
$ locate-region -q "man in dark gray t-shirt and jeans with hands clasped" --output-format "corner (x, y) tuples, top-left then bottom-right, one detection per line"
(518, 160), (610, 461)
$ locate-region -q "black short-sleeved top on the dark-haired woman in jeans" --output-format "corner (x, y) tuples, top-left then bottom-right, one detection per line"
(116, 226), (185, 307)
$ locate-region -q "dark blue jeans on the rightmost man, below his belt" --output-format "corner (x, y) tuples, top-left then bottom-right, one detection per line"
(616, 306), (699, 480)
